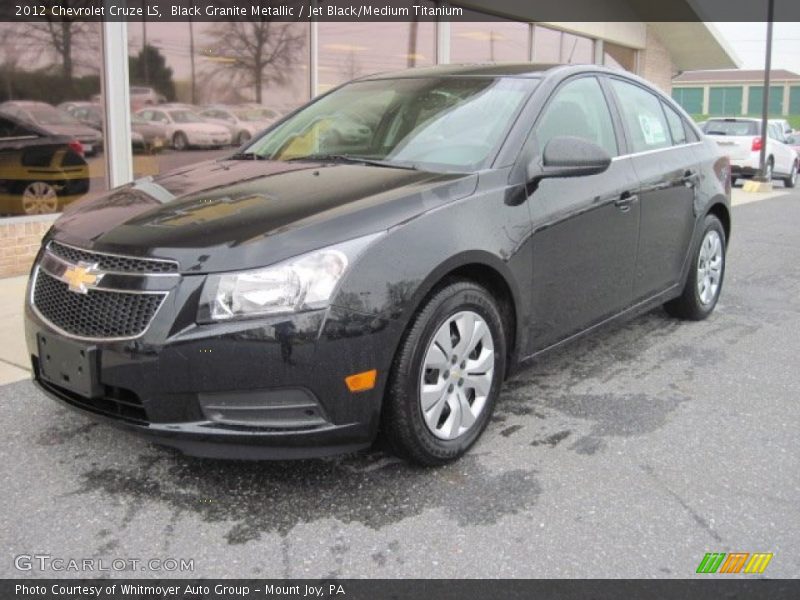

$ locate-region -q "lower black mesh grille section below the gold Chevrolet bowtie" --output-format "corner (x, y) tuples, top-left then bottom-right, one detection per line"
(33, 270), (164, 338)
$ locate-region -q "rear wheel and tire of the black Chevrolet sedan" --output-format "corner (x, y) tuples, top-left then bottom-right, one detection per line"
(664, 215), (726, 321)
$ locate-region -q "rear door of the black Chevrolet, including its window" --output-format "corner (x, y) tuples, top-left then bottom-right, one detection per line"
(609, 78), (699, 301)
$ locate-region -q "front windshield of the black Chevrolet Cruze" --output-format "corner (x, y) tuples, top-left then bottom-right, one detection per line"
(241, 77), (537, 170)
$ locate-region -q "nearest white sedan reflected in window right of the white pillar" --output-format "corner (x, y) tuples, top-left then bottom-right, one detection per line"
(136, 106), (231, 150)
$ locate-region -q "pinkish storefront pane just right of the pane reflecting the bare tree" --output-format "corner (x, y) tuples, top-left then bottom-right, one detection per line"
(317, 21), (436, 93)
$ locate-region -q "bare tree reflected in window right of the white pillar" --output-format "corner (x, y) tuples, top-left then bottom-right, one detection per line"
(203, 21), (306, 103)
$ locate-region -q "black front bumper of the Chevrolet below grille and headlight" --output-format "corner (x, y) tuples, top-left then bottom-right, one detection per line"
(26, 276), (393, 459)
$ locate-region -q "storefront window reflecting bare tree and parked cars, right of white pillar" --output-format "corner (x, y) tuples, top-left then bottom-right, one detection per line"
(128, 21), (310, 177)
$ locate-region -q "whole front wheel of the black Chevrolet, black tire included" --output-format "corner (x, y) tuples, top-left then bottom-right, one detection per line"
(382, 280), (506, 466)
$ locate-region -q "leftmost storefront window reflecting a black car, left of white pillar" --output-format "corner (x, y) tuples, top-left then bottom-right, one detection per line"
(0, 22), (107, 217)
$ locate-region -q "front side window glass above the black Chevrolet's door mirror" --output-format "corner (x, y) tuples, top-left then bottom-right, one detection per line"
(535, 77), (619, 156)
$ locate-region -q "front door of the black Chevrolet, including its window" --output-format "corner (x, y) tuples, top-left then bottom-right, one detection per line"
(529, 75), (639, 351)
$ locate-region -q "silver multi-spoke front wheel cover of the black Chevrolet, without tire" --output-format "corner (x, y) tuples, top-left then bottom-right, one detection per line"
(419, 311), (495, 440)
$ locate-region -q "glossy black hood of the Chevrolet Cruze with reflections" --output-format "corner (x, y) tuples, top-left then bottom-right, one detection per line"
(51, 160), (478, 273)
